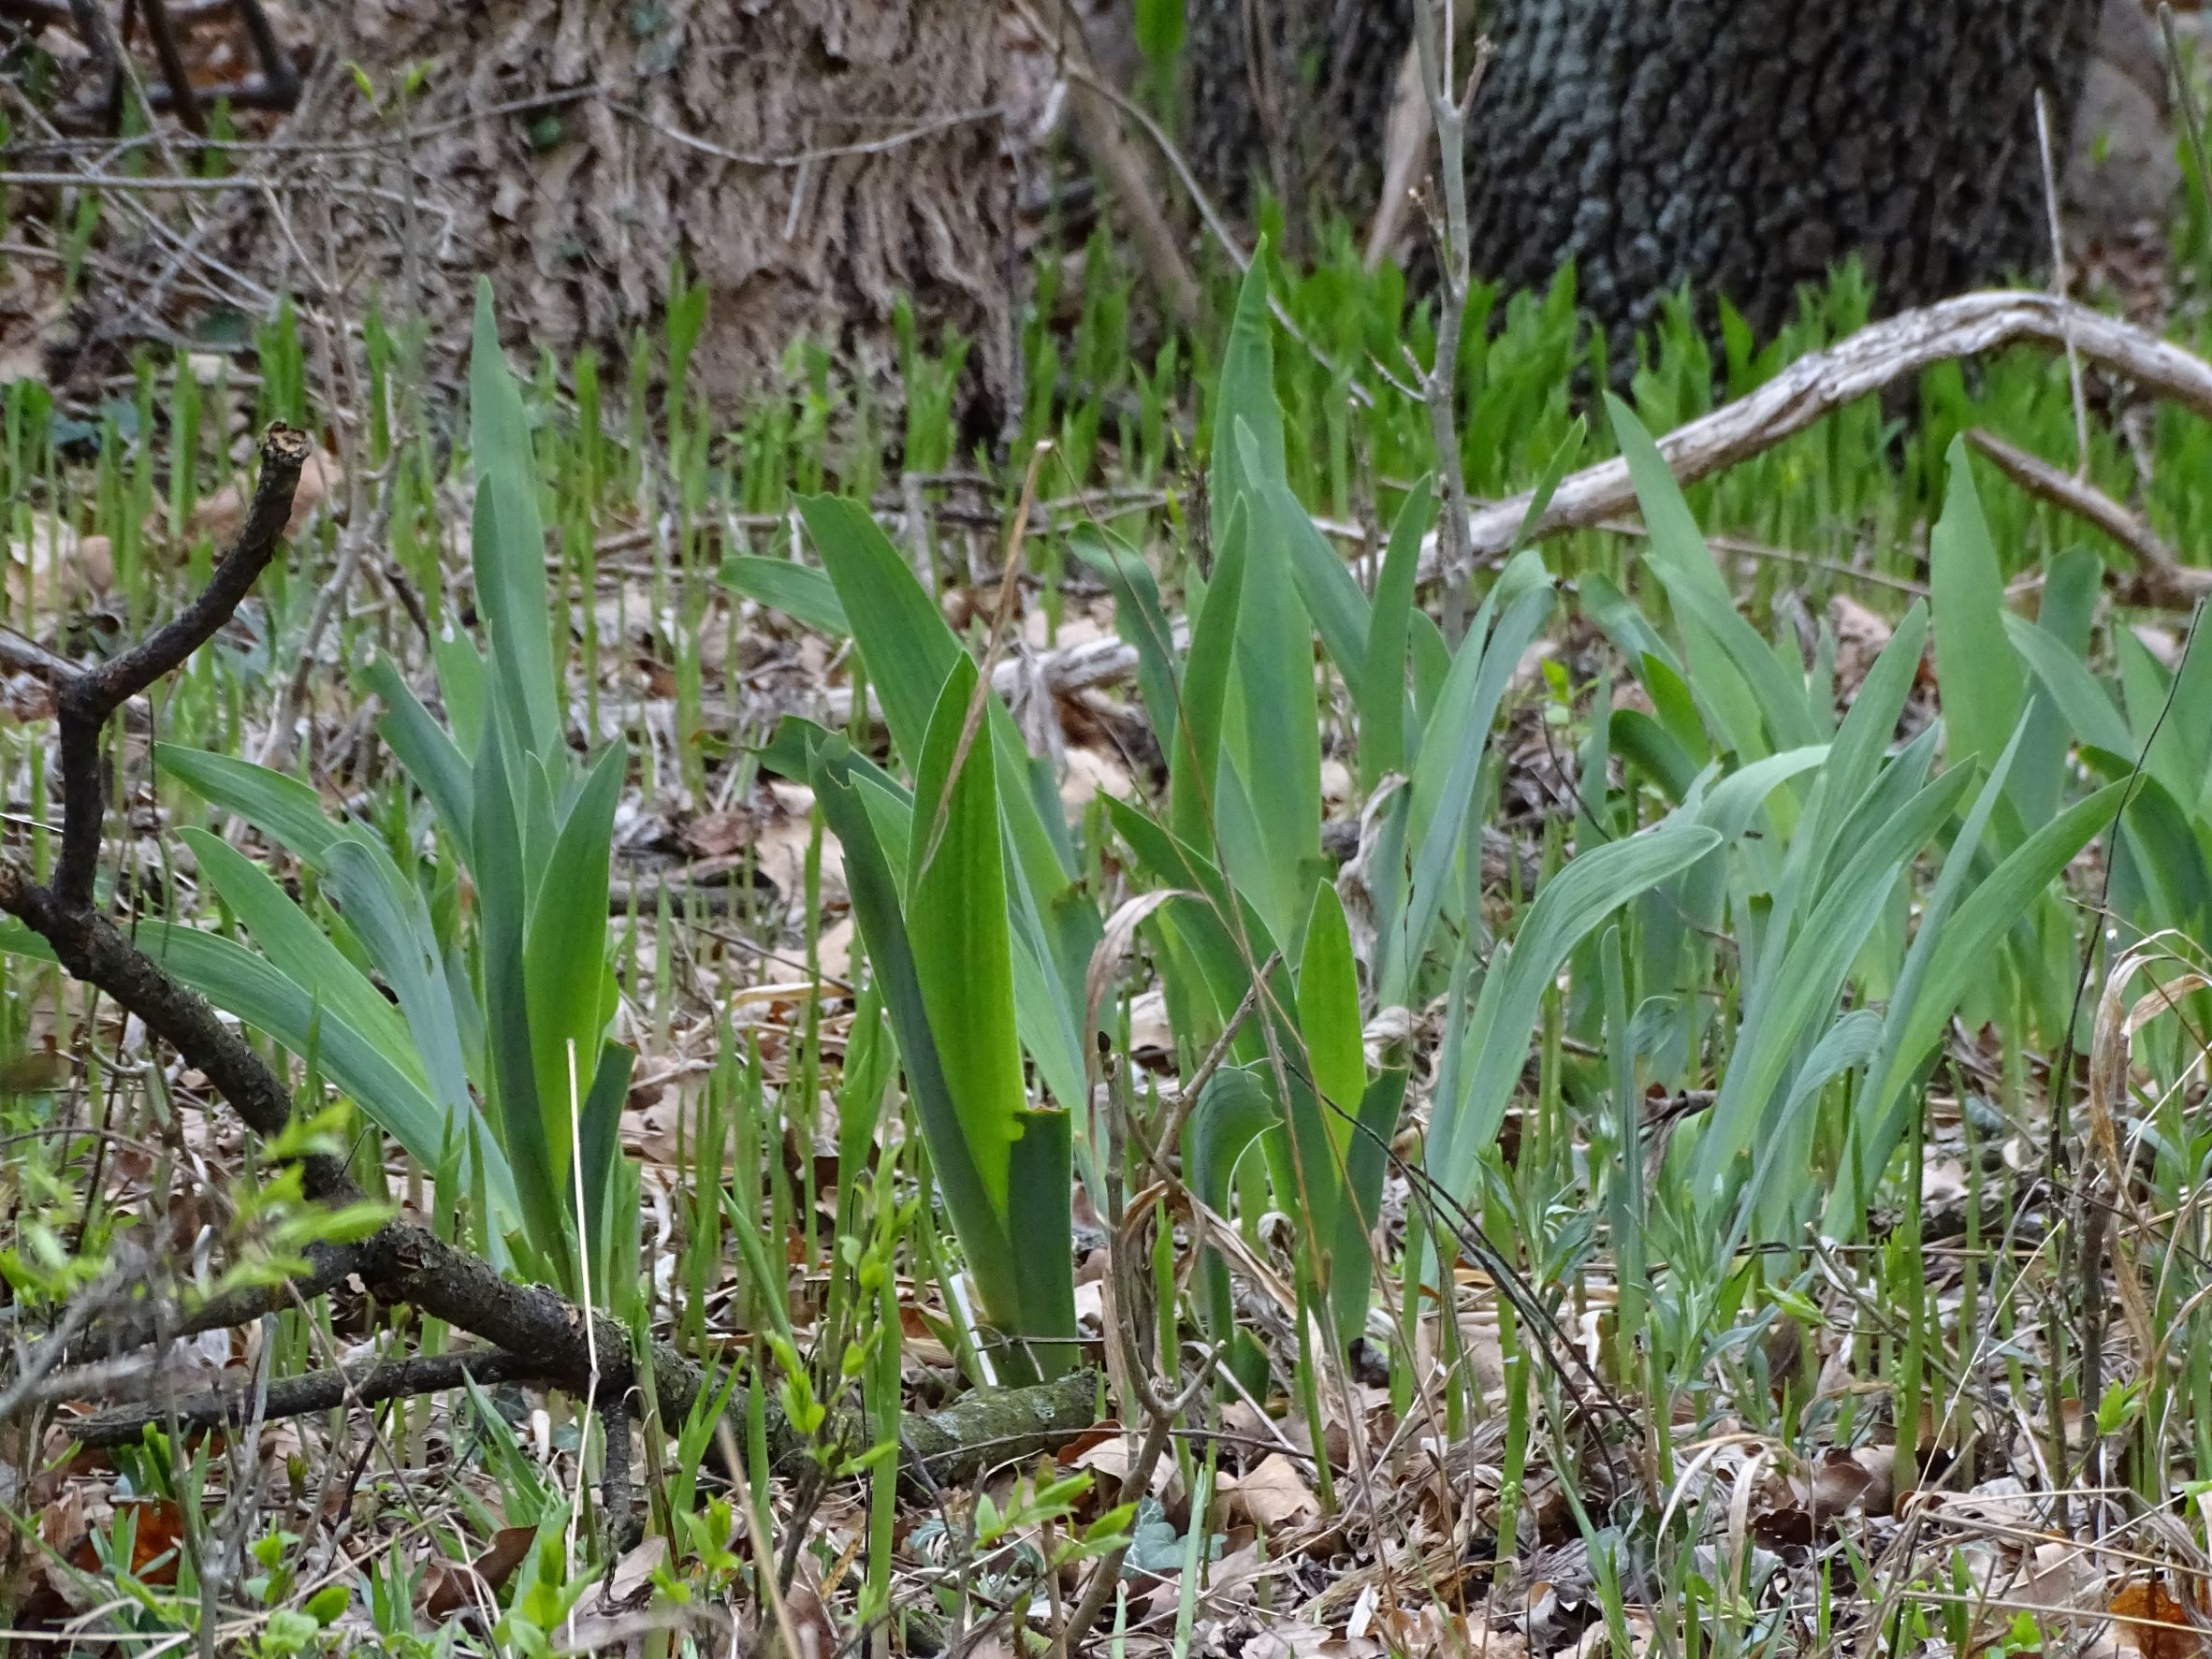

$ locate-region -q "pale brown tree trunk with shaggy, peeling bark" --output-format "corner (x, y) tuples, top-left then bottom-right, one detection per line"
(259, 0), (1017, 429)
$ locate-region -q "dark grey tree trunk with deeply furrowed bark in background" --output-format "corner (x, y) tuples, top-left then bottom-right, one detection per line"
(1187, 0), (2102, 345)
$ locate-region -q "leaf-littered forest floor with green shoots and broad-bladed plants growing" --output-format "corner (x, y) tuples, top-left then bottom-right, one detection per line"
(0, 3), (2212, 1659)
